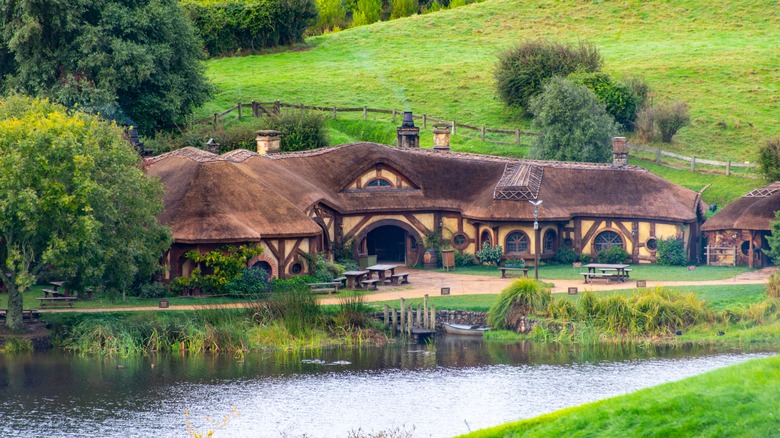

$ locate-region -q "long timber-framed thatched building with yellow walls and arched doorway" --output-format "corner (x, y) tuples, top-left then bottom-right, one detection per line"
(146, 134), (703, 277)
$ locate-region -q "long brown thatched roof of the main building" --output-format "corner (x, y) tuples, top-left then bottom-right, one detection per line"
(147, 143), (698, 241)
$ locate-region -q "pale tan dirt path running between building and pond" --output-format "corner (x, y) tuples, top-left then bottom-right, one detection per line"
(35, 268), (777, 313)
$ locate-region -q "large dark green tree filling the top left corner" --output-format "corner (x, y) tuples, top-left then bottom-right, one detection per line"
(0, 0), (210, 134)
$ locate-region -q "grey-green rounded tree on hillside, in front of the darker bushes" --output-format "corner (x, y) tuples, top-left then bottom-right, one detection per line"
(531, 78), (618, 163)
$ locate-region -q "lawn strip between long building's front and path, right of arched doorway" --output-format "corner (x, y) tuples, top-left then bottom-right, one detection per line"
(432, 265), (750, 281)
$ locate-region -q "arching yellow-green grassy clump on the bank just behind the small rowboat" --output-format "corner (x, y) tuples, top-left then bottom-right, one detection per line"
(487, 278), (552, 330)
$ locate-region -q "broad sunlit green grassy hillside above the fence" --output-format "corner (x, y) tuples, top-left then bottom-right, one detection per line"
(203, 0), (780, 162)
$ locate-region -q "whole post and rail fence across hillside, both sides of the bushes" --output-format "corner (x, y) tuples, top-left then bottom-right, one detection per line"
(196, 100), (758, 178)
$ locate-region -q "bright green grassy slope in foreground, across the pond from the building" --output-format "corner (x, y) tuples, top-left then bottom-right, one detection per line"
(461, 356), (780, 438)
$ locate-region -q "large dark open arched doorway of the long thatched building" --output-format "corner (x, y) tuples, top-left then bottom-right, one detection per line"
(355, 219), (423, 266)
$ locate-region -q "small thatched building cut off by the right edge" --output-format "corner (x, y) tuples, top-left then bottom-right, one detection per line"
(702, 182), (780, 267)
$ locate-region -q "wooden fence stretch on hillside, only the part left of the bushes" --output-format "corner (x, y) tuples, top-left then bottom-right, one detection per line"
(197, 100), (539, 146)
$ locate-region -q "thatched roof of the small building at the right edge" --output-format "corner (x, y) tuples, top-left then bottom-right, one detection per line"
(701, 181), (780, 231)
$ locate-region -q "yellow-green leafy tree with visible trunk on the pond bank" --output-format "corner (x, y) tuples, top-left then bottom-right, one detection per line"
(0, 96), (170, 330)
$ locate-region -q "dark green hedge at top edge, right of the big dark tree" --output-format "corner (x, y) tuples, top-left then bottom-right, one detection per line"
(182, 0), (317, 56)
